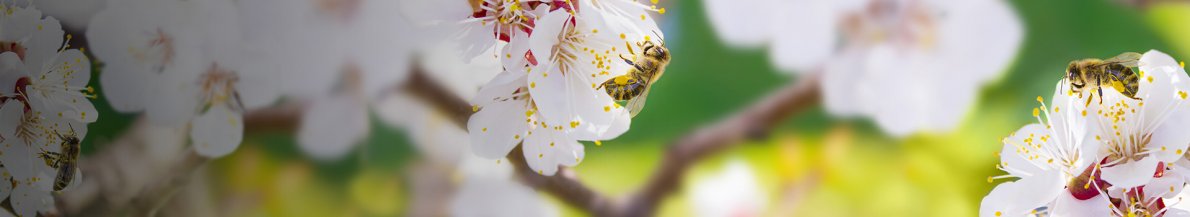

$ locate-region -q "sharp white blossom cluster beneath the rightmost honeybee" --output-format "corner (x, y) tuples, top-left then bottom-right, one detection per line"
(979, 50), (1190, 216)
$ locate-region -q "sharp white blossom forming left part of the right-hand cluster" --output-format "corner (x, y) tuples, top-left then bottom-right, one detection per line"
(979, 85), (1107, 216)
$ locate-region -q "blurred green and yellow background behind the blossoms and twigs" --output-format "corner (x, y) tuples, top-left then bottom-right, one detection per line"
(84, 0), (1190, 216)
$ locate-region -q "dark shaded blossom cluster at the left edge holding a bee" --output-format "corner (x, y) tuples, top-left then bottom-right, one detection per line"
(0, 1), (99, 216)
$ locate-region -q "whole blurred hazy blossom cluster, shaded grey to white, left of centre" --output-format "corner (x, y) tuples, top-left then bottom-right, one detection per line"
(86, 0), (420, 160)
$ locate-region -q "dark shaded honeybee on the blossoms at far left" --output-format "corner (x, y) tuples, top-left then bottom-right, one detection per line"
(38, 130), (81, 192)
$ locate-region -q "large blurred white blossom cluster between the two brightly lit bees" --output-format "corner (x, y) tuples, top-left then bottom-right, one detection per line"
(704, 0), (1025, 136)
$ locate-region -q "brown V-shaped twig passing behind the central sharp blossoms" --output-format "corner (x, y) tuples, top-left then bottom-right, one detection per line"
(409, 67), (819, 216)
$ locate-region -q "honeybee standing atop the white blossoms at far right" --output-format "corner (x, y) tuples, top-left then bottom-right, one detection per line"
(1066, 52), (1140, 105)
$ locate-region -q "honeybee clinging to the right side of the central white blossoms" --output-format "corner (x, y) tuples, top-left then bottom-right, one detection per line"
(599, 32), (670, 117)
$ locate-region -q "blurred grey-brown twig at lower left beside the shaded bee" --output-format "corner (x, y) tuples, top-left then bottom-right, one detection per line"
(56, 120), (208, 216)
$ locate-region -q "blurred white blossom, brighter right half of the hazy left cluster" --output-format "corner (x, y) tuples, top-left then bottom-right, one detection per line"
(230, 0), (421, 160)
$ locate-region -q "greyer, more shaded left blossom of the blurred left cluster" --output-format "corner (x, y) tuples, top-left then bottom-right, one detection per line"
(88, 0), (280, 157)
